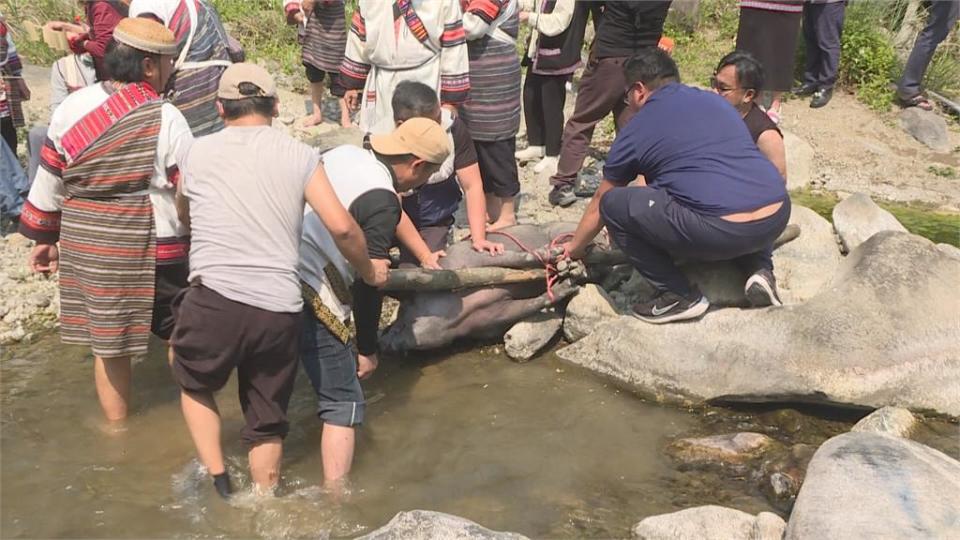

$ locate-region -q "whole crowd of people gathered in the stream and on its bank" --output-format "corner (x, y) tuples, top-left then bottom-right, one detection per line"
(0, 0), (958, 496)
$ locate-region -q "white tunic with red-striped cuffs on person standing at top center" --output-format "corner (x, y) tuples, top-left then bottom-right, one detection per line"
(340, 0), (470, 133)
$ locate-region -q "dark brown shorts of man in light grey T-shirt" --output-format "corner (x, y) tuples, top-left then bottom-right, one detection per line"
(170, 285), (302, 444)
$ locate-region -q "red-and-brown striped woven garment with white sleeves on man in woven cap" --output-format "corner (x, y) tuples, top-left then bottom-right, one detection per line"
(20, 83), (190, 358)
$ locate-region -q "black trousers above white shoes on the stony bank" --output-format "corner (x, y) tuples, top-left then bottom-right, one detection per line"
(523, 69), (570, 157)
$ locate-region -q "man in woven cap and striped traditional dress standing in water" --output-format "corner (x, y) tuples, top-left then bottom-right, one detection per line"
(20, 19), (192, 421)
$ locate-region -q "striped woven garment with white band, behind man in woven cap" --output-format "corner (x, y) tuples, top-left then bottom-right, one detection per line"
(130, 0), (231, 137)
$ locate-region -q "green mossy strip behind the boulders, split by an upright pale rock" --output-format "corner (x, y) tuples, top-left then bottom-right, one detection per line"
(790, 189), (960, 247)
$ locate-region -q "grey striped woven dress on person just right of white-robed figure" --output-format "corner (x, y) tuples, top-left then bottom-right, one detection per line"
(462, 0), (520, 141)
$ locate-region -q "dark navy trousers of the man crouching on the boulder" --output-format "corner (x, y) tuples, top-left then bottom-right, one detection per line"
(600, 187), (790, 295)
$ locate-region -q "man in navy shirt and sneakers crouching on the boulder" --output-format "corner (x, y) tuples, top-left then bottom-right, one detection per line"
(564, 48), (790, 323)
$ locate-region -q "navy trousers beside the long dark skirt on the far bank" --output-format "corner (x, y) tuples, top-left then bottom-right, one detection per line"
(803, 1), (847, 88)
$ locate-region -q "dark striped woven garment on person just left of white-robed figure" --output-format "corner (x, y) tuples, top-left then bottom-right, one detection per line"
(284, 0), (347, 73)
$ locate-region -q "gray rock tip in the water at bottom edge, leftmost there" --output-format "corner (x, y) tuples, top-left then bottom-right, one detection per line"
(357, 510), (526, 540)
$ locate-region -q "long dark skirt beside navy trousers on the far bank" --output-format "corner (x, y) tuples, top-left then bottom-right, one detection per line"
(737, 8), (803, 92)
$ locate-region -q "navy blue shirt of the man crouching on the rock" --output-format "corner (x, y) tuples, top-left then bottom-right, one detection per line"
(603, 83), (787, 216)
